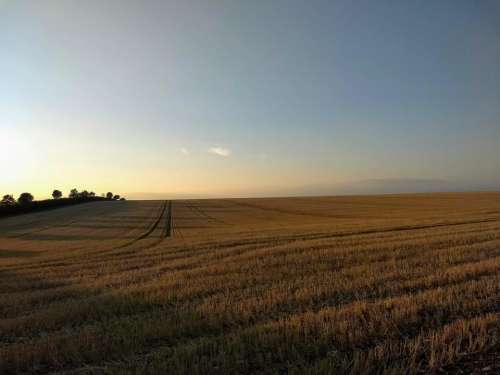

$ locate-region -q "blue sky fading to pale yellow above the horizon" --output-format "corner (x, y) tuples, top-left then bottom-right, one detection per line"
(0, 0), (500, 198)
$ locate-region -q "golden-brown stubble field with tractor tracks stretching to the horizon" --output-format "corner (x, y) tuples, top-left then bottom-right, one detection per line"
(0, 193), (500, 374)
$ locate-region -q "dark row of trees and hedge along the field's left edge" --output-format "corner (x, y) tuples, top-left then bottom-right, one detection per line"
(0, 189), (125, 217)
